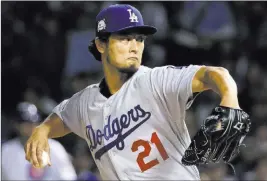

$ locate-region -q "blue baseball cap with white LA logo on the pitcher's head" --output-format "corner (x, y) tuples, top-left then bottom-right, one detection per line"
(96, 4), (157, 37)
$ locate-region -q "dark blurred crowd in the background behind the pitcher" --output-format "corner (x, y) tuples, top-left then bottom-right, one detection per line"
(1, 1), (267, 180)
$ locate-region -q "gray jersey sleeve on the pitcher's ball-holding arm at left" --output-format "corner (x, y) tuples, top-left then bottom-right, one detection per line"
(52, 92), (84, 138)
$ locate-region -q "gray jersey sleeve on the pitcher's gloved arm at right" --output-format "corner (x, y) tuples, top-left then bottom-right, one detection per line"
(150, 65), (202, 112)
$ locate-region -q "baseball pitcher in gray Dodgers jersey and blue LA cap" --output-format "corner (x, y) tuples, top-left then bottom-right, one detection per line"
(25, 4), (250, 180)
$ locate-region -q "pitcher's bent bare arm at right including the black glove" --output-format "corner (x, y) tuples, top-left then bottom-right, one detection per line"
(182, 66), (251, 165)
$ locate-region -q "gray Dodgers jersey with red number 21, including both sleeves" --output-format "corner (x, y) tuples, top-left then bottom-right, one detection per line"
(53, 65), (203, 180)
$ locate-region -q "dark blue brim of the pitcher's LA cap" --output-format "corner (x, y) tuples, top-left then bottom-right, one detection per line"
(110, 25), (157, 35)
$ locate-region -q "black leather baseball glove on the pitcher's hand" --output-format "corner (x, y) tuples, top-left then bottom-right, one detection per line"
(182, 106), (251, 166)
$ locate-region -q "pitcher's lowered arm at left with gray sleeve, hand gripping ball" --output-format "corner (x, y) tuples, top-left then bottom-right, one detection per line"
(25, 91), (84, 168)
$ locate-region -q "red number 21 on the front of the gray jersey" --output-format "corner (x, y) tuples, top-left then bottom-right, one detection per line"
(132, 132), (169, 172)
